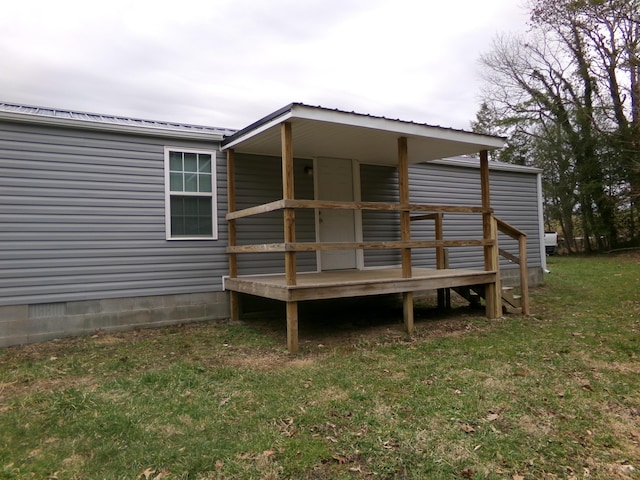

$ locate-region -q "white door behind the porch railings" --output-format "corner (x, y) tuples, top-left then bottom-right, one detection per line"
(314, 158), (357, 270)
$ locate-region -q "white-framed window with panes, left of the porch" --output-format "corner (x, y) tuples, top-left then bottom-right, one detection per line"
(164, 147), (218, 240)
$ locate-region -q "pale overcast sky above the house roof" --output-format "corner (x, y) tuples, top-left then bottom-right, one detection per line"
(0, 0), (527, 129)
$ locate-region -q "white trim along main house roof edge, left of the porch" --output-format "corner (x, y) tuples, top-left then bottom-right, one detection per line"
(0, 111), (224, 142)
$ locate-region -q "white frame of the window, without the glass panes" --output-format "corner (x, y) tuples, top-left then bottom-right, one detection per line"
(164, 146), (218, 240)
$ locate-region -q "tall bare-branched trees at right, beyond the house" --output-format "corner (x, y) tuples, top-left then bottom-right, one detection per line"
(481, 0), (640, 249)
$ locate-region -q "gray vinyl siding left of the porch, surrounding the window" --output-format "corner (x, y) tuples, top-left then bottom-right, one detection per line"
(0, 122), (227, 305)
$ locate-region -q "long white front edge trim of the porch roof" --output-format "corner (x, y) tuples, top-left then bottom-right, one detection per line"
(290, 104), (505, 148)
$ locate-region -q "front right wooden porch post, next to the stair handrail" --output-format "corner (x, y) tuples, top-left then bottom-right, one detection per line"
(480, 150), (502, 318)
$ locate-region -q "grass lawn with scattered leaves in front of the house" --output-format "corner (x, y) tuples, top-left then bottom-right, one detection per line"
(0, 253), (640, 480)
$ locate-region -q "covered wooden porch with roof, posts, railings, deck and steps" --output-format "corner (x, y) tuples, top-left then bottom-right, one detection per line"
(223, 104), (526, 352)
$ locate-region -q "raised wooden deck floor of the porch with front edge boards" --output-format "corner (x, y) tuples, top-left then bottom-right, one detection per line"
(224, 268), (497, 302)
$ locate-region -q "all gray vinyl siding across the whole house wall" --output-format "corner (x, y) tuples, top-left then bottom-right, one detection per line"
(0, 117), (541, 306)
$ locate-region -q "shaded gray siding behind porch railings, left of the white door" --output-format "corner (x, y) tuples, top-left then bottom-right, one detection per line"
(235, 154), (316, 275)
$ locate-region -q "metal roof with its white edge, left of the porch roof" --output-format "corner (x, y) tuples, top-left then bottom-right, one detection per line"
(0, 102), (235, 141)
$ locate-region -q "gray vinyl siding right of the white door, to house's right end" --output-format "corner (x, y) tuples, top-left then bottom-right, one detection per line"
(361, 162), (541, 269)
